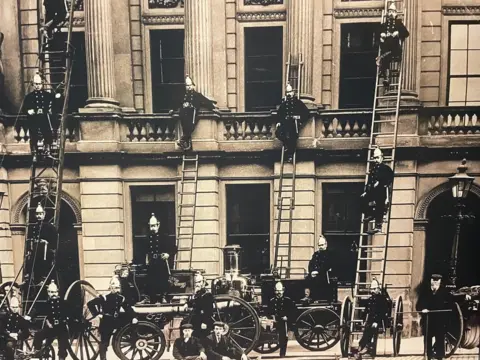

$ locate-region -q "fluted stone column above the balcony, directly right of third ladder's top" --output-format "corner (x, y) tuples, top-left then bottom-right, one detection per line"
(287, 0), (314, 101)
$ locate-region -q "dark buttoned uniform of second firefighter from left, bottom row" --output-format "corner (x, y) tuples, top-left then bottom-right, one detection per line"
(33, 297), (69, 359)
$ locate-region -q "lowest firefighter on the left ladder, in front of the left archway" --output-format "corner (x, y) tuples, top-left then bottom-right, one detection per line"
(25, 203), (58, 285)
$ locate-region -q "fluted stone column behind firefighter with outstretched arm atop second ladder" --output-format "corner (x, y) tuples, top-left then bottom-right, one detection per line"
(184, 0), (213, 99)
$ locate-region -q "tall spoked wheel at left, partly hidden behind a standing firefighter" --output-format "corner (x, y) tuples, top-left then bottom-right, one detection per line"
(65, 280), (100, 360)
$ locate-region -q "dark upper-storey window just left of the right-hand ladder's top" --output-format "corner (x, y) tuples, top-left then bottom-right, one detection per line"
(339, 23), (380, 108)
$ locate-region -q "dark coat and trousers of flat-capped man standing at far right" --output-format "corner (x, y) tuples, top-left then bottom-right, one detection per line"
(416, 286), (453, 359)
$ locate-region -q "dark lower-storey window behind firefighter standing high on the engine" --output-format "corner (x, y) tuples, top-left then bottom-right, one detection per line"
(132, 185), (176, 266)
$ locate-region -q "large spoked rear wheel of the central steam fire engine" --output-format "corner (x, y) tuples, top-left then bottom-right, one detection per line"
(213, 295), (260, 354)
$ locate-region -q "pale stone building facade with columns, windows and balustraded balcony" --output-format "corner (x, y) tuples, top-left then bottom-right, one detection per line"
(0, 0), (480, 334)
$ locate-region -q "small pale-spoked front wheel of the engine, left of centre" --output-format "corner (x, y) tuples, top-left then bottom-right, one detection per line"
(112, 321), (166, 360)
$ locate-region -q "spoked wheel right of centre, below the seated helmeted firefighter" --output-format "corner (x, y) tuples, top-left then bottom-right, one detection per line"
(294, 307), (340, 351)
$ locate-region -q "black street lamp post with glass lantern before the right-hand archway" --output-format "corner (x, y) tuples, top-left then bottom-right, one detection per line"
(448, 159), (474, 286)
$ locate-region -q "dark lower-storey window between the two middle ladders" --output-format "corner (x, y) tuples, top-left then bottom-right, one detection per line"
(226, 184), (270, 275)
